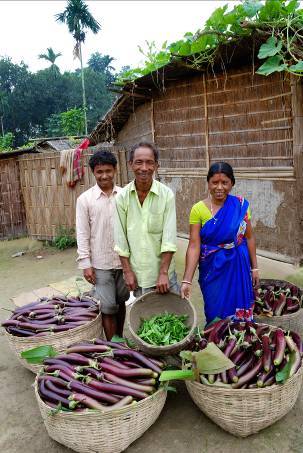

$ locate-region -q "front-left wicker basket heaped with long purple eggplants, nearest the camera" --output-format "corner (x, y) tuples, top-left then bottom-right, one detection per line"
(35, 339), (167, 453)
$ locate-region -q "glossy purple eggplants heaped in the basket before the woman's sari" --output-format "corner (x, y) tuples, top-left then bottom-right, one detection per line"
(192, 320), (303, 389)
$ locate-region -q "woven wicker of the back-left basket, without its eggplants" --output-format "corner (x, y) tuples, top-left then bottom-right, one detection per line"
(5, 314), (103, 373)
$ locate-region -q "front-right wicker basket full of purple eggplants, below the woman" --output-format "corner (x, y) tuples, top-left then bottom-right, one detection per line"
(184, 320), (303, 437)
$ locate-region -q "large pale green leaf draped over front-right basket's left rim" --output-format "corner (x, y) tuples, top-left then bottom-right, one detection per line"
(192, 343), (235, 374)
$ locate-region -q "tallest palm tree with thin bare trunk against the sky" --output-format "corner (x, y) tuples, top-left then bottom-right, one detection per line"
(55, 0), (101, 135)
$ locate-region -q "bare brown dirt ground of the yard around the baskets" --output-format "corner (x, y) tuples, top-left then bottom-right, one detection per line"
(0, 239), (303, 453)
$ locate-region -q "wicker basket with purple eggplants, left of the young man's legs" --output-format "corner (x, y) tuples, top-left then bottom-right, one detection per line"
(1, 296), (103, 373)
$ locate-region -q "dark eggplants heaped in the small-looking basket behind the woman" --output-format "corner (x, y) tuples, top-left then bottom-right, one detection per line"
(254, 283), (303, 317)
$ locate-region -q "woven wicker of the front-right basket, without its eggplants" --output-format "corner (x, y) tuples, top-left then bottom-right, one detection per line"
(186, 367), (302, 437)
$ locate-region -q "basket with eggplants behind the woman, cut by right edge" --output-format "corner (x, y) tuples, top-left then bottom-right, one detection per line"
(254, 279), (303, 335)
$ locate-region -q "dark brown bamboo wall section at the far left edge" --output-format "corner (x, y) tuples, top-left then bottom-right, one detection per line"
(0, 157), (27, 239)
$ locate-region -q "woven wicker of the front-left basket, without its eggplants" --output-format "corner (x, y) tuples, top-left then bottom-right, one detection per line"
(35, 383), (167, 453)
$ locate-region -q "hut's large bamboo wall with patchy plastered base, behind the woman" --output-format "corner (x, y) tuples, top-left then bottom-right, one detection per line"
(118, 67), (303, 261)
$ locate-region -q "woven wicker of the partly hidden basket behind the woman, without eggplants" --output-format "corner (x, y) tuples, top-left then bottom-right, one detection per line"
(254, 279), (303, 335)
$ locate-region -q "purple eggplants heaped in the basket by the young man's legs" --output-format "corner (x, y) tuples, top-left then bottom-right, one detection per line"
(1, 296), (99, 337)
